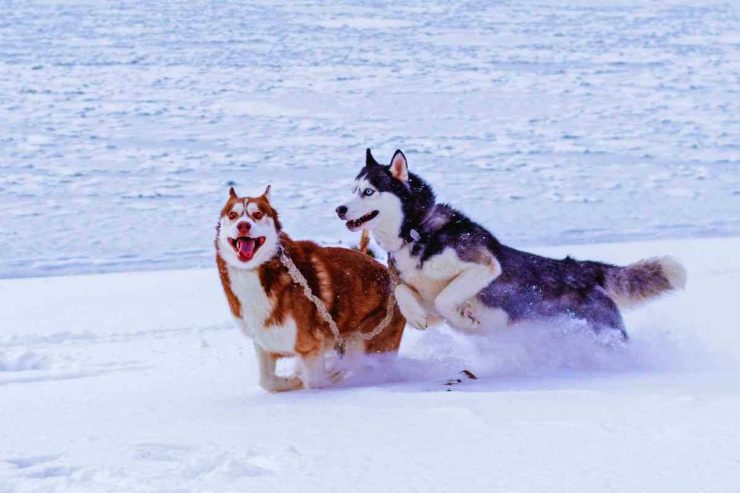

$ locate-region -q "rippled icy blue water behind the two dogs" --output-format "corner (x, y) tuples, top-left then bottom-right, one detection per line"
(0, 0), (740, 277)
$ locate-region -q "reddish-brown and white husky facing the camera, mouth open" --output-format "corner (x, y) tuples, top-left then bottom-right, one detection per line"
(215, 187), (406, 391)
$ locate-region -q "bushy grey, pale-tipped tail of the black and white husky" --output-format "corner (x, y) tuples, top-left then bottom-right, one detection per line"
(600, 257), (686, 308)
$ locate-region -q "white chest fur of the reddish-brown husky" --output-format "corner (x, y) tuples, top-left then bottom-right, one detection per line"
(229, 268), (298, 353)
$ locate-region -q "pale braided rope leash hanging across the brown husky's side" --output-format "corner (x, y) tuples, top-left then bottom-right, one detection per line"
(278, 245), (396, 358)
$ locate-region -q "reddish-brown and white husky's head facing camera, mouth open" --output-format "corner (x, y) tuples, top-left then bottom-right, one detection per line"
(216, 186), (282, 269)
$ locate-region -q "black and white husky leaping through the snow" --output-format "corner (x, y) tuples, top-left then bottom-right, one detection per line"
(337, 149), (686, 337)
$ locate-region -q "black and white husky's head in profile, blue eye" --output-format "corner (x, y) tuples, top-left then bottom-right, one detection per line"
(336, 149), (434, 246)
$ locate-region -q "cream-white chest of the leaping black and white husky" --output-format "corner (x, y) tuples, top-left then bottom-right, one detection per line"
(393, 246), (462, 306)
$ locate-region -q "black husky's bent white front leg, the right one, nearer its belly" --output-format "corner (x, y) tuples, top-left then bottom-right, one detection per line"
(434, 258), (501, 330)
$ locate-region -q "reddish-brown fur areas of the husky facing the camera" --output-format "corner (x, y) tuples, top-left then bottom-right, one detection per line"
(216, 191), (406, 388)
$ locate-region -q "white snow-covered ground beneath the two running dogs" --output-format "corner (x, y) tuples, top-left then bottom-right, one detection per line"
(0, 238), (740, 493)
